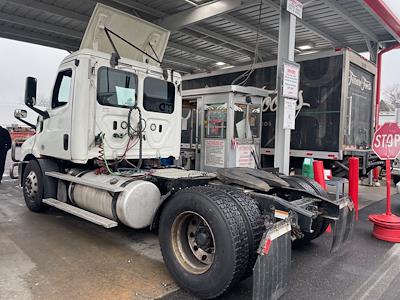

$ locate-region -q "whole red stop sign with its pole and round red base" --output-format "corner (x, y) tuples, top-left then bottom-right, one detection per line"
(368, 123), (400, 243)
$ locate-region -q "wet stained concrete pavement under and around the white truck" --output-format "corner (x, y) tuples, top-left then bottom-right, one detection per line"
(0, 150), (400, 300)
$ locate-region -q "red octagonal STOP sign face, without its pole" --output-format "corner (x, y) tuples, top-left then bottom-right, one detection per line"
(372, 123), (400, 160)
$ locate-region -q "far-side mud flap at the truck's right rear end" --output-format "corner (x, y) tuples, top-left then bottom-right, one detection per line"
(331, 199), (355, 253)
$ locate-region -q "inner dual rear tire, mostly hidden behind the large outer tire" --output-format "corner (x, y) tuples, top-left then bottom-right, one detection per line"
(211, 185), (265, 278)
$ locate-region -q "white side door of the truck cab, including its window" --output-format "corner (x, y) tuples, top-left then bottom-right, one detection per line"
(37, 62), (75, 159)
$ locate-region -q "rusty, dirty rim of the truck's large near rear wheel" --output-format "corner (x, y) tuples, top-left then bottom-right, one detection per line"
(171, 211), (215, 274)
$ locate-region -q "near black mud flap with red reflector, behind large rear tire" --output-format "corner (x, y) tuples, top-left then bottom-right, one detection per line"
(253, 218), (292, 300)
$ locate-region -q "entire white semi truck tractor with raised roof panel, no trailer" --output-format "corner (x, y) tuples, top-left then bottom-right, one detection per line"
(11, 5), (354, 299)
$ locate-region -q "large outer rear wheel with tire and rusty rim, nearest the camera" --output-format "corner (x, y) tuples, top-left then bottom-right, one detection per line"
(159, 186), (249, 299)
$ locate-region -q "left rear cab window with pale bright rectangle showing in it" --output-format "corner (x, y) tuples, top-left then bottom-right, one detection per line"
(97, 67), (137, 107)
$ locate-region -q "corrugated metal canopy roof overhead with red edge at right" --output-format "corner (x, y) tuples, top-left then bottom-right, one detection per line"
(0, 0), (400, 72)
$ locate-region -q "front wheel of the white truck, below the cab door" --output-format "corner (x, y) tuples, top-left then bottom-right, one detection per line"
(22, 160), (48, 212)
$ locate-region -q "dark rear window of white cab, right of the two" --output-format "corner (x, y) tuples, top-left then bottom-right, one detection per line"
(143, 77), (175, 114)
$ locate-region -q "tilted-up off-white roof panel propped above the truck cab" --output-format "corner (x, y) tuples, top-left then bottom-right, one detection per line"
(80, 3), (169, 66)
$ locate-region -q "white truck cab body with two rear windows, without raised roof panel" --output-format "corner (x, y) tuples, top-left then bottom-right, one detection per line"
(22, 49), (181, 164)
